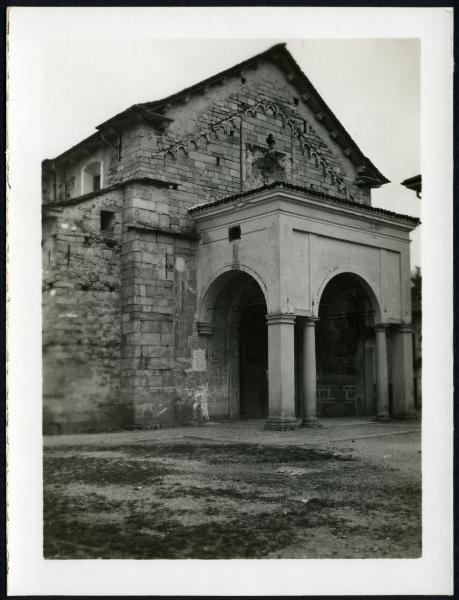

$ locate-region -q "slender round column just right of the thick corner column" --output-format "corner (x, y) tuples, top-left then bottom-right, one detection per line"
(302, 318), (317, 427)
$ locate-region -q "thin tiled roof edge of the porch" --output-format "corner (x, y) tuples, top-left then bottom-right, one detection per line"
(188, 181), (420, 227)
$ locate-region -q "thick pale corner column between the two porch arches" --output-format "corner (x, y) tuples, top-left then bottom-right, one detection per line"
(265, 313), (299, 431)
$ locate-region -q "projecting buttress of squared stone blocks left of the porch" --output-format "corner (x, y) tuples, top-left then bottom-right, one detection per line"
(121, 184), (207, 425)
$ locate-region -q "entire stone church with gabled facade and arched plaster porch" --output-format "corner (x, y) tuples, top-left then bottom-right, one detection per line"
(42, 44), (418, 433)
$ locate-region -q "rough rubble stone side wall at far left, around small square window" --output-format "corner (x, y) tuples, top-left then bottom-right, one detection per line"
(43, 192), (123, 433)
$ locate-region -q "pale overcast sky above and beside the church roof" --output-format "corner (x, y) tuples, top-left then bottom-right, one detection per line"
(41, 38), (420, 266)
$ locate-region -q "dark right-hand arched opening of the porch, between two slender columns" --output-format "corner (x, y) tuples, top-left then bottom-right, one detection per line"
(316, 273), (377, 417)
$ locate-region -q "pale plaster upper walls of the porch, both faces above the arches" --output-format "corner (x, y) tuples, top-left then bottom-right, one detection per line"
(192, 191), (411, 323)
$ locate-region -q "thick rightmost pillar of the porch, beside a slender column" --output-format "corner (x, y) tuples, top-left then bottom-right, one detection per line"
(391, 324), (417, 419)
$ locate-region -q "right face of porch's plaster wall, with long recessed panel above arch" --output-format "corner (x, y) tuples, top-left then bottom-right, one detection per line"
(280, 199), (411, 322)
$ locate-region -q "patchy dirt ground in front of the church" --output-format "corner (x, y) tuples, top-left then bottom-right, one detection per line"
(44, 424), (421, 559)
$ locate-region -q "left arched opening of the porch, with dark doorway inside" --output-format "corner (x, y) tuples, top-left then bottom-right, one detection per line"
(198, 270), (268, 419)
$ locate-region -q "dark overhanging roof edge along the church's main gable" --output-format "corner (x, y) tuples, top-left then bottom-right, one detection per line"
(43, 44), (389, 187)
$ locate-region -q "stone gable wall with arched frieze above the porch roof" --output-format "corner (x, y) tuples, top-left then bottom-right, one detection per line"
(108, 63), (370, 212)
